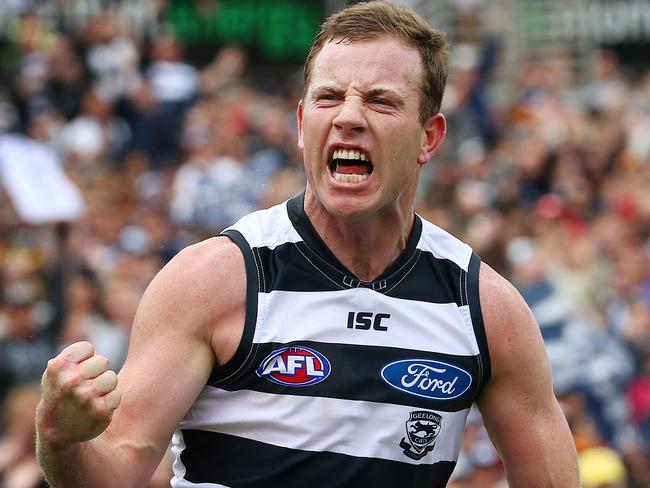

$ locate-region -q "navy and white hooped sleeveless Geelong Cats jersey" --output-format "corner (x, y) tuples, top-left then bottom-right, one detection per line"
(172, 194), (490, 488)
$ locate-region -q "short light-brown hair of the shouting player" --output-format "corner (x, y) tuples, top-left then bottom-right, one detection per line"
(303, 1), (449, 124)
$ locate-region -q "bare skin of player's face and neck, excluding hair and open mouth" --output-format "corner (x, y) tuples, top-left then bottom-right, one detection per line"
(297, 38), (445, 279)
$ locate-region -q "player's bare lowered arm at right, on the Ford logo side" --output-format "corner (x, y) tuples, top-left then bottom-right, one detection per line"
(478, 264), (580, 488)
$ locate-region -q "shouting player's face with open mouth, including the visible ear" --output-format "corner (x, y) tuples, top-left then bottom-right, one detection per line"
(298, 37), (445, 217)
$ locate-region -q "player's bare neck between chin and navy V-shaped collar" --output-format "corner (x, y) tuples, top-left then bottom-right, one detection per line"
(305, 189), (414, 281)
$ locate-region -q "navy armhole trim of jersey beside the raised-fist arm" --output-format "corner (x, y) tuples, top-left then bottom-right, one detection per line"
(207, 229), (259, 386)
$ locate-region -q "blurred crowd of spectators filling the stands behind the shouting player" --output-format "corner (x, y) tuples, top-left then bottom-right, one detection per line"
(0, 0), (650, 488)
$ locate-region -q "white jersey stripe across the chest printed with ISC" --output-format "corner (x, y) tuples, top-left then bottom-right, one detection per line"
(253, 288), (479, 355)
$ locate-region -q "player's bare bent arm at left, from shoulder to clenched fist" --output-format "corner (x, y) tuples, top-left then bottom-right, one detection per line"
(37, 238), (245, 488)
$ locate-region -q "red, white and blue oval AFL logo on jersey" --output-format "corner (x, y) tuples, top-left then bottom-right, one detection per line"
(256, 346), (332, 386)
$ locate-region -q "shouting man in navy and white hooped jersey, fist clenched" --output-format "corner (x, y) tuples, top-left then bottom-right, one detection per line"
(37, 3), (578, 488)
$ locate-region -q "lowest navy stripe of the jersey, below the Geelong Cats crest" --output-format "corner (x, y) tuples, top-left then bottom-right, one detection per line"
(175, 430), (455, 488)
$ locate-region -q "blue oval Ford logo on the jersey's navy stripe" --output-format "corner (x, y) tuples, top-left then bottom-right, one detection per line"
(381, 359), (472, 400)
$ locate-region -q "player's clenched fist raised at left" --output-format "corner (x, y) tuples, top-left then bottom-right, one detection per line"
(36, 342), (121, 448)
